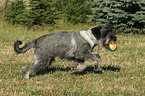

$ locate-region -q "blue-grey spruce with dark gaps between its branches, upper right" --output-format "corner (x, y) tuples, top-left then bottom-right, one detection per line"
(89, 0), (145, 33)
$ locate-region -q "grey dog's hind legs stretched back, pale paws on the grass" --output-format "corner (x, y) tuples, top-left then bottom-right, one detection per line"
(22, 57), (54, 79)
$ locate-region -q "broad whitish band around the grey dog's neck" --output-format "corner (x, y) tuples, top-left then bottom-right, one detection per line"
(80, 30), (97, 47)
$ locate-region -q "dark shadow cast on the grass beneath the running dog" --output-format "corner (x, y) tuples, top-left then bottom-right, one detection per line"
(37, 66), (121, 75)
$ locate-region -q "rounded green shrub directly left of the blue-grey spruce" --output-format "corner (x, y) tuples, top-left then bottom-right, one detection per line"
(61, 0), (91, 24)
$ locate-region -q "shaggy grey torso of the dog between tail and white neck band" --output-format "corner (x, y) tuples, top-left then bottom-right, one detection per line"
(35, 32), (89, 58)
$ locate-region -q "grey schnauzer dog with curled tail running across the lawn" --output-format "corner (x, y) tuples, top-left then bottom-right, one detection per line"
(14, 24), (116, 79)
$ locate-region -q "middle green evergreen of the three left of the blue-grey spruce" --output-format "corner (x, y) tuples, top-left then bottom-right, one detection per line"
(23, 0), (59, 26)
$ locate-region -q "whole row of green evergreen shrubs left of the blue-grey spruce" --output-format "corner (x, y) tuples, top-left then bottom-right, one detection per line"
(5, 0), (91, 27)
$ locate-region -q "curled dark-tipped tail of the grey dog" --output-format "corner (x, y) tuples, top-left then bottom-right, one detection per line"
(14, 40), (34, 54)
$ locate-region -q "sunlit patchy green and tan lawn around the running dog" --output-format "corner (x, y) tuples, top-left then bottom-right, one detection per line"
(0, 21), (145, 96)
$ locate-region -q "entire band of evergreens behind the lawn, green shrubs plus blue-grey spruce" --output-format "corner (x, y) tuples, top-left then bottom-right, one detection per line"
(5, 0), (145, 33)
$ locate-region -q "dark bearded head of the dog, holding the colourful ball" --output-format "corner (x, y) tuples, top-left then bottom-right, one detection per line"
(91, 24), (117, 49)
